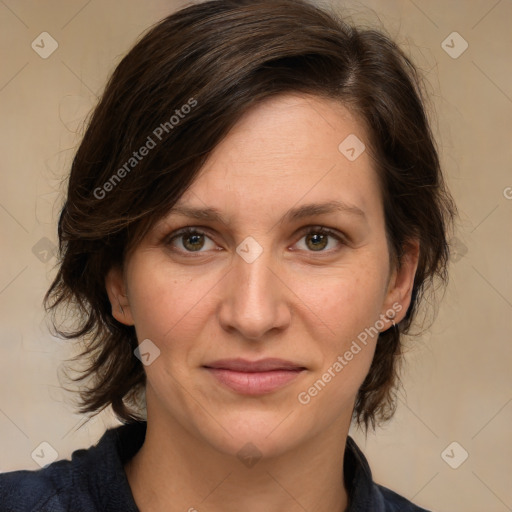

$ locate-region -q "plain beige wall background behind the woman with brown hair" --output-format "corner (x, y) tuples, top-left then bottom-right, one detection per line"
(0, 0), (512, 512)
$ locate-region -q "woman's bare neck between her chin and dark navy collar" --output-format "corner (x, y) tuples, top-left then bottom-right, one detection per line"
(125, 412), (349, 512)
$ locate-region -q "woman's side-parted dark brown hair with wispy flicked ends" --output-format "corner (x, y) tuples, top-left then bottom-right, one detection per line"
(45, 0), (456, 428)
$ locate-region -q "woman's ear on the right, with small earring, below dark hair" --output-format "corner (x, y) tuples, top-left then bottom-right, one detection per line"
(383, 239), (420, 323)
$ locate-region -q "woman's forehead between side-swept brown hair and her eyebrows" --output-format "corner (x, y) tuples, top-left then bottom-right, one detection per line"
(170, 94), (381, 224)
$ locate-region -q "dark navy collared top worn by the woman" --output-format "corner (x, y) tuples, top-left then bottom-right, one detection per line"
(0, 422), (427, 512)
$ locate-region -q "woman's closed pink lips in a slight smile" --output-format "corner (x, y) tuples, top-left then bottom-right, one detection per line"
(204, 358), (306, 396)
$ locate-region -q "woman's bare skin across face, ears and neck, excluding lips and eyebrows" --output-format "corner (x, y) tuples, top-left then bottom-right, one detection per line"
(106, 94), (419, 512)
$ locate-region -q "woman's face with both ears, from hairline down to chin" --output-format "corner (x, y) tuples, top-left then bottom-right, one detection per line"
(107, 94), (416, 456)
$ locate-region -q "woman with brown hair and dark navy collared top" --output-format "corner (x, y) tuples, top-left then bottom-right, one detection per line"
(0, 0), (455, 512)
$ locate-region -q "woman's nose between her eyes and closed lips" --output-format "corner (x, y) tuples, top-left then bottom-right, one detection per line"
(219, 243), (292, 341)
